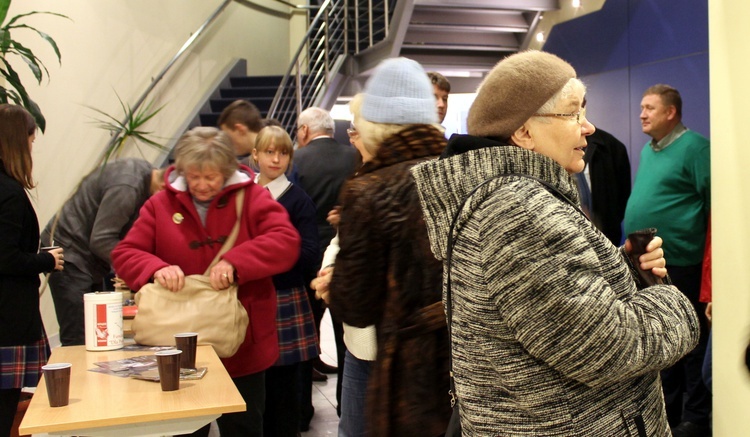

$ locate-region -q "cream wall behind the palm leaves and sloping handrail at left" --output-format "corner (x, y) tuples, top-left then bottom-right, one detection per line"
(8, 0), (304, 337)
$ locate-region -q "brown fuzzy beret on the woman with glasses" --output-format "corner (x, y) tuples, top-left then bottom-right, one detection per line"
(466, 50), (576, 139)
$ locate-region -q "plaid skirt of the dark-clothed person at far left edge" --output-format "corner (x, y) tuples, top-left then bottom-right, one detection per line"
(0, 335), (50, 389)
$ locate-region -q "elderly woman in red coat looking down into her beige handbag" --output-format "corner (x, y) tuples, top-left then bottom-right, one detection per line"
(112, 127), (300, 436)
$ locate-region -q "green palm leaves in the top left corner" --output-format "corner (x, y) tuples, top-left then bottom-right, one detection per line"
(0, 0), (68, 132)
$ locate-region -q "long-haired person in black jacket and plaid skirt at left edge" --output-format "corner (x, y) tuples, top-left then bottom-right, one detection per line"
(0, 104), (63, 435)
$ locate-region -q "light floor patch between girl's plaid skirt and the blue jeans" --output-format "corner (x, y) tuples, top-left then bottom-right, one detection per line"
(302, 311), (339, 437)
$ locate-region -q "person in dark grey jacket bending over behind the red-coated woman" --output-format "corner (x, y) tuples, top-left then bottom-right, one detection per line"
(42, 159), (164, 346)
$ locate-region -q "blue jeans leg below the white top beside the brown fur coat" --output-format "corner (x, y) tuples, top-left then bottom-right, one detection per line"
(339, 351), (372, 437)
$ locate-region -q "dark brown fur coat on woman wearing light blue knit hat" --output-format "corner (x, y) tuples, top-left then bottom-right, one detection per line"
(330, 125), (451, 437)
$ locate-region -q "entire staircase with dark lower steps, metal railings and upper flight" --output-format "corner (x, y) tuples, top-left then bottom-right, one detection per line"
(200, 0), (560, 136)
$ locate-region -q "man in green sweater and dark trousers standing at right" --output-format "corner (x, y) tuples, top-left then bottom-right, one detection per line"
(624, 84), (711, 437)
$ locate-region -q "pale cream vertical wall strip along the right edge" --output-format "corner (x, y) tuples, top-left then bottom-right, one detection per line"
(708, 0), (750, 437)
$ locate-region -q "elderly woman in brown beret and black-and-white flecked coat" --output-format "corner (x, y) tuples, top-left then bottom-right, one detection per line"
(412, 51), (699, 437)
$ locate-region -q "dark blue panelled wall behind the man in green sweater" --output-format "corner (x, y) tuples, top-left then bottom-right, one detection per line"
(544, 0), (711, 178)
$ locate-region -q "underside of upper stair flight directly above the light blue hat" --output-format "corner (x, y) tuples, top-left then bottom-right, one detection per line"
(356, 0), (560, 97)
